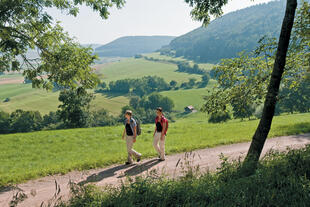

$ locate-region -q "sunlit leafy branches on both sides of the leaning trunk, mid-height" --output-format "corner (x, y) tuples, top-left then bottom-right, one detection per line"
(203, 3), (310, 118)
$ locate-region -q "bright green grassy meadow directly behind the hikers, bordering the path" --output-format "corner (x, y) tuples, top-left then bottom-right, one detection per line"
(0, 113), (310, 186)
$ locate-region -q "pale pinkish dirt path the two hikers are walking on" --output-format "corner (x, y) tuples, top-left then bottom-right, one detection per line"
(0, 134), (310, 207)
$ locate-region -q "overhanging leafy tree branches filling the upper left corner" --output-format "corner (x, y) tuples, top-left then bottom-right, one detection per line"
(0, 0), (124, 89)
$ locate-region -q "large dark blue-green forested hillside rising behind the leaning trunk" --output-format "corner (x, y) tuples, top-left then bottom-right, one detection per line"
(162, 0), (286, 62)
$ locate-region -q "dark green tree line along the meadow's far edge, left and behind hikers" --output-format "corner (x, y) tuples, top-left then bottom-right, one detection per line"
(0, 89), (174, 134)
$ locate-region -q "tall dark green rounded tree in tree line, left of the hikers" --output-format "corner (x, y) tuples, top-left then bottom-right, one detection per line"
(59, 88), (93, 128)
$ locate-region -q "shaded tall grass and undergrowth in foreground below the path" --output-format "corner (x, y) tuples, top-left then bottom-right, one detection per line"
(60, 146), (310, 207)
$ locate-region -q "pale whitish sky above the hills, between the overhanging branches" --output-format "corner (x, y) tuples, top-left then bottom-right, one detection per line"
(48, 0), (270, 44)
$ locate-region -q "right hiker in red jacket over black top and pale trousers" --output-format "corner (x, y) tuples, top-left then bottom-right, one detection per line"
(153, 107), (168, 161)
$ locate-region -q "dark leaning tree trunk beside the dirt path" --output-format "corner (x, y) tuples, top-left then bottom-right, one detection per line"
(244, 0), (297, 170)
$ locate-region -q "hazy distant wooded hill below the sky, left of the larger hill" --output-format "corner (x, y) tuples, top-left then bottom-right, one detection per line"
(95, 36), (175, 57)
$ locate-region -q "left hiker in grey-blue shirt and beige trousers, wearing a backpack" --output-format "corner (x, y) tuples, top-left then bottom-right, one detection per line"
(123, 110), (141, 165)
